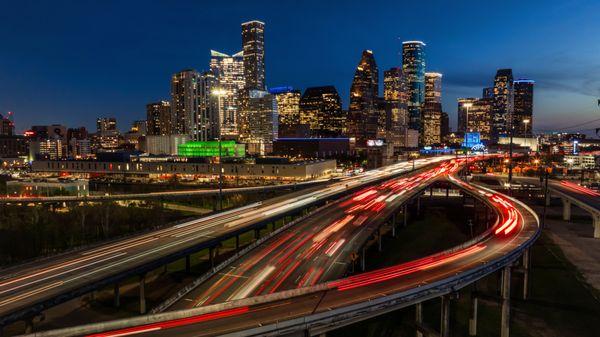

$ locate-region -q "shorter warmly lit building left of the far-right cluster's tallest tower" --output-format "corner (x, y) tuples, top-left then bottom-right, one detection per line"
(457, 98), (494, 140)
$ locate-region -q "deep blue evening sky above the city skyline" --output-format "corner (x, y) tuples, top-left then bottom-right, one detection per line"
(0, 0), (600, 135)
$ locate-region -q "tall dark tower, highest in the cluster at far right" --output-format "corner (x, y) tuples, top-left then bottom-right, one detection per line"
(492, 69), (514, 140)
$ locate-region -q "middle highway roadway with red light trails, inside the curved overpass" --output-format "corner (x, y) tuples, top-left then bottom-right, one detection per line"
(166, 159), (459, 309)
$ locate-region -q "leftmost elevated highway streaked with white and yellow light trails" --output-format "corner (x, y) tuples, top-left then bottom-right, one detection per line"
(0, 157), (449, 326)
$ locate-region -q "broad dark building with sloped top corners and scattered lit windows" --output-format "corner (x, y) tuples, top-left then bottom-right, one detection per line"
(300, 86), (346, 137)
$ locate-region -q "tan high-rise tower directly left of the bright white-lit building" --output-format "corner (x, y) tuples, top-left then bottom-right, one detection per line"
(171, 69), (200, 139)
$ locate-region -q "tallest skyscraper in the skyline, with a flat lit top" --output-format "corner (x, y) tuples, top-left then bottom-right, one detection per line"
(242, 20), (265, 90)
